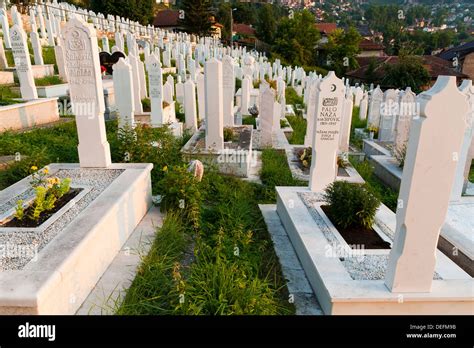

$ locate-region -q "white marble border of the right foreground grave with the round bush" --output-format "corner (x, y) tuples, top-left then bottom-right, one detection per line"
(276, 187), (474, 315)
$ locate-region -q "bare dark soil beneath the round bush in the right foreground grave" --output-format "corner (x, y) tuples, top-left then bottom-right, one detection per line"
(321, 205), (390, 249)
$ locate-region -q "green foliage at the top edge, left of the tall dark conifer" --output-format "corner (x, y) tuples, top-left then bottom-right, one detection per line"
(90, 0), (155, 25)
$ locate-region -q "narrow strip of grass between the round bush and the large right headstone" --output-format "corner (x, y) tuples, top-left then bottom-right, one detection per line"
(350, 156), (398, 212)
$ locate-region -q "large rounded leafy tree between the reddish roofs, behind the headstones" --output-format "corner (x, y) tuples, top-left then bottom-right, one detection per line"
(273, 10), (321, 66)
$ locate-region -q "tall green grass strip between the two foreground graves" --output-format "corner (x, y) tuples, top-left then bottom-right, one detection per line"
(116, 170), (294, 315)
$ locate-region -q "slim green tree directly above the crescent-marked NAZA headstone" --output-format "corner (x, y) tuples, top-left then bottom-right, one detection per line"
(325, 27), (362, 77)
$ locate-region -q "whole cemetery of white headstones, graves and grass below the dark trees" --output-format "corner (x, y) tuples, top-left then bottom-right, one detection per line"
(0, 3), (474, 324)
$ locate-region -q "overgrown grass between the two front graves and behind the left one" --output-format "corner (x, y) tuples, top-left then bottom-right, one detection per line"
(0, 121), (301, 314)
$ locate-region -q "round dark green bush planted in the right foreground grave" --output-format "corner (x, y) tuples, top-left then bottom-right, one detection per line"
(324, 181), (380, 228)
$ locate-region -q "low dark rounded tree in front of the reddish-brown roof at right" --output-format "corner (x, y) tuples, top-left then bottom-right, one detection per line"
(382, 55), (431, 93)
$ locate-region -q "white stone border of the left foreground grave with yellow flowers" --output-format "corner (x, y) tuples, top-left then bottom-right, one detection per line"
(0, 163), (153, 315)
